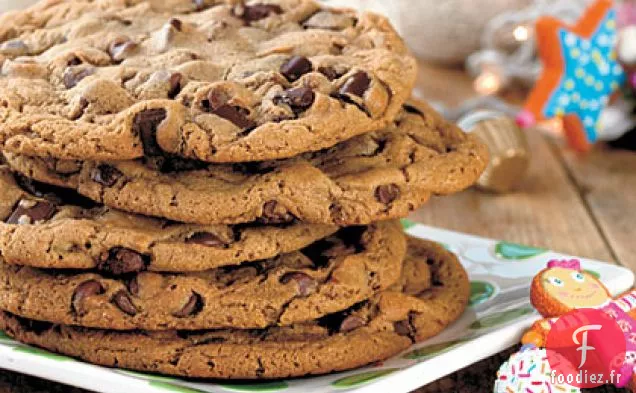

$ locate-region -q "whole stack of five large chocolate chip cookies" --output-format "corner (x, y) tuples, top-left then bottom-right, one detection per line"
(0, 0), (487, 379)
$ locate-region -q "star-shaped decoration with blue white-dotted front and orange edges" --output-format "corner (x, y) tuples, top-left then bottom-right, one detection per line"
(517, 0), (626, 151)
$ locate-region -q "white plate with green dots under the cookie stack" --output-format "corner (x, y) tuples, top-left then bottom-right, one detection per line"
(0, 220), (634, 393)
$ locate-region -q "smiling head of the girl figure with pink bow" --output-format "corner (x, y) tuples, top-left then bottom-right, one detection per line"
(530, 260), (612, 318)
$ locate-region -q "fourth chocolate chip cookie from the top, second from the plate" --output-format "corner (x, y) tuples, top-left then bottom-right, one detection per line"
(0, 221), (406, 330)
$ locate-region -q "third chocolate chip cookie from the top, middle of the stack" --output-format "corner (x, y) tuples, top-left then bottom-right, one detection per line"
(0, 166), (337, 275)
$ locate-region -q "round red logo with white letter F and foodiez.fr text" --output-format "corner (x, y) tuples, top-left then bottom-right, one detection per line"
(546, 309), (632, 388)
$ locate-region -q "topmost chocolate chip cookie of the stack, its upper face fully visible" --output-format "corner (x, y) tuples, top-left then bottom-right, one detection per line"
(0, 0), (416, 162)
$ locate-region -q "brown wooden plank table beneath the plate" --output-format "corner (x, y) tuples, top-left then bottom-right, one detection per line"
(0, 9), (636, 393)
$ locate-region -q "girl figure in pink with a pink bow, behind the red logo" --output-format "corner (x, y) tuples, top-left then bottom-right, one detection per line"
(522, 260), (636, 387)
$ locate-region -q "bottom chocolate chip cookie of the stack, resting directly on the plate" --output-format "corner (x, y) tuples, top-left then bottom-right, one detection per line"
(0, 239), (470, 379)
